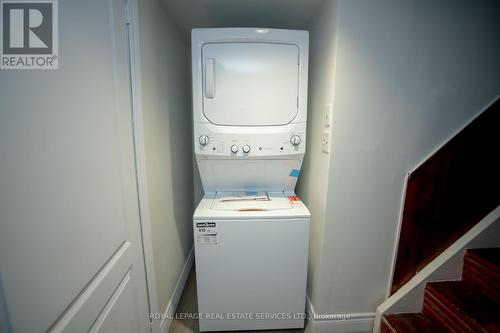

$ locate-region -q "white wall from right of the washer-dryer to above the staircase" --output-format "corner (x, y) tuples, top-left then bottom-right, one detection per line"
(299, 0), (500, 313)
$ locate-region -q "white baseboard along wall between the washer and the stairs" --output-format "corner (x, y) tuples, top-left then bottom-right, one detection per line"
(307, 297), (375, 333)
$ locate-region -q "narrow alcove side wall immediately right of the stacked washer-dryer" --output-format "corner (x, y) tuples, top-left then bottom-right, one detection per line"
(296, 1), (337, 303)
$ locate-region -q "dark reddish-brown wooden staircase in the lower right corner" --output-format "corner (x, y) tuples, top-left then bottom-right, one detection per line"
(381, 248), (500, 333)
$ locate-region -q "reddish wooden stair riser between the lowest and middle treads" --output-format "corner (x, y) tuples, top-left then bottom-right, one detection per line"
(422, 288), (486, 333)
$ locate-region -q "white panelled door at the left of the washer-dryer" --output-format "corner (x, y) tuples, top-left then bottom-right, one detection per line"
(0, 0), (149, 333)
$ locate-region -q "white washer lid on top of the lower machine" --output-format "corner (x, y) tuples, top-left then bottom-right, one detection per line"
(210, 191), (293, 212)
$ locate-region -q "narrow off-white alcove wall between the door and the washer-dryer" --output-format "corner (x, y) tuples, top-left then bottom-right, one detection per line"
(138, 0), (193, 312)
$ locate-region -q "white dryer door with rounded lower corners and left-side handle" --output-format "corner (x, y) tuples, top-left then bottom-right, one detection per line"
(202, 43), (299, 126)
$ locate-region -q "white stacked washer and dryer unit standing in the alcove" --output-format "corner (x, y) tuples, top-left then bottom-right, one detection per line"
(192, 28), (310, 331)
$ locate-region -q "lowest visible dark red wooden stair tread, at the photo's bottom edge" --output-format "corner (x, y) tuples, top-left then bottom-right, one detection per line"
(384, 313), (446, 333)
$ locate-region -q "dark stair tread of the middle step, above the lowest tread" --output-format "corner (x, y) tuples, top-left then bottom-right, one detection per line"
(426, 281), (500, 332)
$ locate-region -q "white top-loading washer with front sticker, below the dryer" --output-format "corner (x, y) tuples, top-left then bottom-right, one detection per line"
(193, 192), (310, 331)
